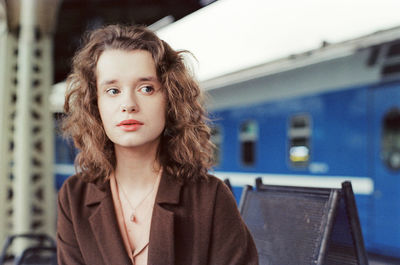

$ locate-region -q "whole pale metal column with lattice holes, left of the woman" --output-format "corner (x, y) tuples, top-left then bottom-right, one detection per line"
(13, 0), (59, 253)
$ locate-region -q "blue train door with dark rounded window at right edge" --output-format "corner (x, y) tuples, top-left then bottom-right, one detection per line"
(370, 83), (400, 256)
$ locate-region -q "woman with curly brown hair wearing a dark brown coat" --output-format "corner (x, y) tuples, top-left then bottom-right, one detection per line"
(57, 25), (258, 265)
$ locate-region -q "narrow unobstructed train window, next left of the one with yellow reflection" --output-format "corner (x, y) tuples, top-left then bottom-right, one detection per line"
(239, 121), (258, 166)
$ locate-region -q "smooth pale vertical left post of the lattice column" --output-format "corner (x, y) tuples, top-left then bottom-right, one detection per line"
(14, 0), (38, 237)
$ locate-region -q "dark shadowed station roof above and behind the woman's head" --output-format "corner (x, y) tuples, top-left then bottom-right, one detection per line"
(54, 0), (215, 82)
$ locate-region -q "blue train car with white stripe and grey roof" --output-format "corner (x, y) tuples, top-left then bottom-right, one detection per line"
(204, 26), (400, 257)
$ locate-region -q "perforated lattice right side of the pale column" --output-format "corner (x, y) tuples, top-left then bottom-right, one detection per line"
(31, 36), (56, 237)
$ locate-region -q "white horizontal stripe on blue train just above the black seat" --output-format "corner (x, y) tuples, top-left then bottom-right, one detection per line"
(212, 171), (374, 195)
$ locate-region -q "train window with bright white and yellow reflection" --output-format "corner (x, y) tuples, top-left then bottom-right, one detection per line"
(288, 115), (311, 168)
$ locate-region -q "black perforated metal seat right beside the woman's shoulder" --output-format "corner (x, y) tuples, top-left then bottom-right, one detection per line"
(239, 178), (368, 265)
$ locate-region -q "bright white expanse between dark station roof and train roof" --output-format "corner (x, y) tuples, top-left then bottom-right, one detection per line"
(157, 0), (400, 81)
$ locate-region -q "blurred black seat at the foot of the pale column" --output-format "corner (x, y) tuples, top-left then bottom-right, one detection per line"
(0, 234), (57, 265)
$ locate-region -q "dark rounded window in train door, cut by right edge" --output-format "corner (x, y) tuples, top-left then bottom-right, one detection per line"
(381, 108), (400, 171)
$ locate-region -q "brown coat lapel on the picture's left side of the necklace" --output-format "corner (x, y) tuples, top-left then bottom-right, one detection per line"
(86, 181), (132, 265)
